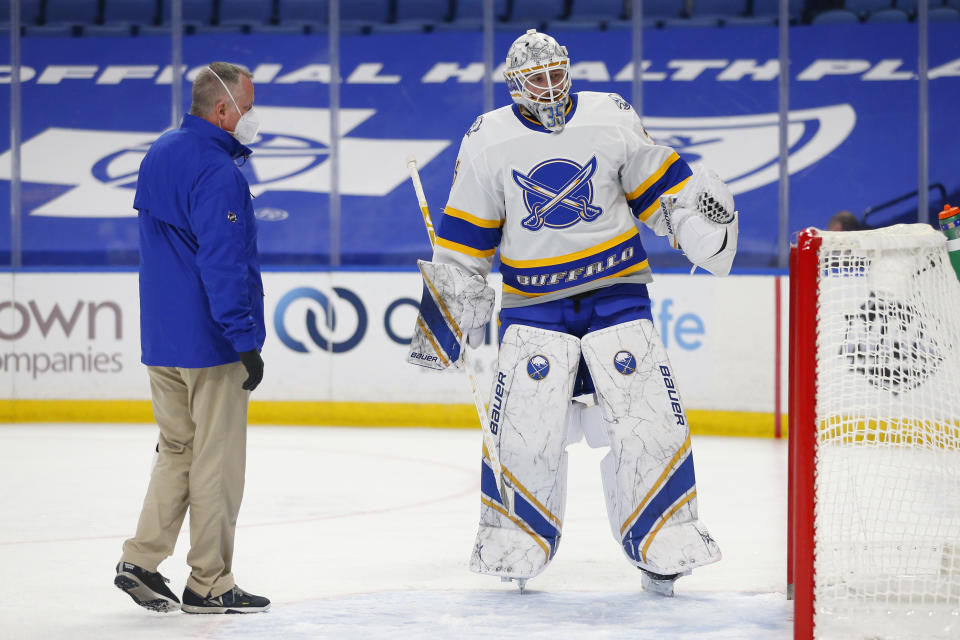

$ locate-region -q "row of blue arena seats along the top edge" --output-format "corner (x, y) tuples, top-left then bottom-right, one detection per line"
(0, 0), (960, 36)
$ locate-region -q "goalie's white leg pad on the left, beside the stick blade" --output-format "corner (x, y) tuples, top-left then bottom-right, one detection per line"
(470, 325), (580, 578)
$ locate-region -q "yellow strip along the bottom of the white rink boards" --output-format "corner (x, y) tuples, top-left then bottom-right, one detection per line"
(0, 400), (786, 438)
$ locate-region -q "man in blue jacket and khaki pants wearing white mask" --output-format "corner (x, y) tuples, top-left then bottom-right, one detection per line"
(114, 62), (270, 613)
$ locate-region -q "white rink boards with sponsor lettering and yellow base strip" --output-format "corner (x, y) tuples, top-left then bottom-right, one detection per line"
(0, 271), (787, 436)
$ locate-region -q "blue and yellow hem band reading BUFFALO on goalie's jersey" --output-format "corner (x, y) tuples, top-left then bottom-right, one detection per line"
(500, 227), (650, 298)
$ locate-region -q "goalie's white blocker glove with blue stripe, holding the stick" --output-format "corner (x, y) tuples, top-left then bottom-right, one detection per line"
(407, 260), (495, 369)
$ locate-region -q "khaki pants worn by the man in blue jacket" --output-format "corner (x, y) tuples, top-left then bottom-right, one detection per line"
(122, 362), (250, 597)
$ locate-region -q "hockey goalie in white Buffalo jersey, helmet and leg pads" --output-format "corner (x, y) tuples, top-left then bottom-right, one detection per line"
(408, 29), (738, 596)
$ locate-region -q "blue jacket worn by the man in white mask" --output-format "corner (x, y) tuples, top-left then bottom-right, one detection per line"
(133, 115), (266, 367)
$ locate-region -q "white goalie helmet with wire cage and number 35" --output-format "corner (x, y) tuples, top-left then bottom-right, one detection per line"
(503, 29), (570, 132)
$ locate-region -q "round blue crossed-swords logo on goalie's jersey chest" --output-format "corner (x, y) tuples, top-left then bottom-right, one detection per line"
(513, 156), (603, 231)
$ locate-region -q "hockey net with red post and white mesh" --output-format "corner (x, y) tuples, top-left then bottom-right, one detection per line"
(788, 224), (960, 640)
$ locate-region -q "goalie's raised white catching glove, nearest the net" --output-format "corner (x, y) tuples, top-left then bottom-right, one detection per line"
(660, 166), (739, 276)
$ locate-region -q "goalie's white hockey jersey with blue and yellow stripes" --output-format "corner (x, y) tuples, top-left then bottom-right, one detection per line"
(434, 91), (691, 307)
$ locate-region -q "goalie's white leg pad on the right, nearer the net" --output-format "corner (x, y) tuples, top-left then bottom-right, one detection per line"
(581, 320), (720, 575)
